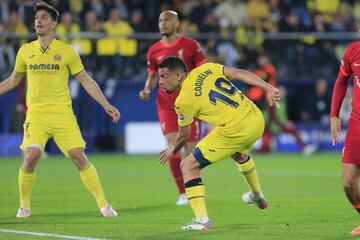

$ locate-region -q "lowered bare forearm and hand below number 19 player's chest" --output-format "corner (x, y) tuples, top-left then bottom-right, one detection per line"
(159, 125), (191, 165)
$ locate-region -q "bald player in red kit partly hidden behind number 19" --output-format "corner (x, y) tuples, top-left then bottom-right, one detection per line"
(139, 10), (205, 205)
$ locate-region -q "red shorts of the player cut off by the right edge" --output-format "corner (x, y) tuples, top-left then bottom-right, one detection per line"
(342, 118), (360, 165)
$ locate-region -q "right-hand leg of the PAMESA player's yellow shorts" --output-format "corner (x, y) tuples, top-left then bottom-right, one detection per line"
(53, 112), (86, 157)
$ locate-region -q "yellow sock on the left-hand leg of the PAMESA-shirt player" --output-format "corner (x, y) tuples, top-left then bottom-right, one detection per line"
(19, 168), (36, 208)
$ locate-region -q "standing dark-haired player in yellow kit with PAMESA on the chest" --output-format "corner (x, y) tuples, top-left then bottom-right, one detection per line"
(0, 2), (120, 218)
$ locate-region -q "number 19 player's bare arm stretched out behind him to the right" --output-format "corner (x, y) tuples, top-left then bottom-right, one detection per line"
(224, 66), (280, 107)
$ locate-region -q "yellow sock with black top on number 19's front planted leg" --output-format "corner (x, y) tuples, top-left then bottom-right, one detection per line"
(185, 178), (208, 219)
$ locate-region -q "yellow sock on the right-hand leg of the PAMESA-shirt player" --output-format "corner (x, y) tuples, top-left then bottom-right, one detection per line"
(80, 164), (106, 208)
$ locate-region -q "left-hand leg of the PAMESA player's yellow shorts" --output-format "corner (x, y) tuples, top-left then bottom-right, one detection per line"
(20, 114), (50, 152)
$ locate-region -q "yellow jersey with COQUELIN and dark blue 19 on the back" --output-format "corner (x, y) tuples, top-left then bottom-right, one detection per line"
(175, 63), (256, 127)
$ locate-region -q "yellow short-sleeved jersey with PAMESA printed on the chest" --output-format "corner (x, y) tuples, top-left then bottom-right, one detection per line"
(15, 39), (84, 112)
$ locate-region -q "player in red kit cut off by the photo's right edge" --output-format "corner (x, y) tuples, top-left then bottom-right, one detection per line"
(330, 42), (360, 235)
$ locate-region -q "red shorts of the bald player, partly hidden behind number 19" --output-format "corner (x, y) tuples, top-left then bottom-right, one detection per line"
(158, 106), (201, 142)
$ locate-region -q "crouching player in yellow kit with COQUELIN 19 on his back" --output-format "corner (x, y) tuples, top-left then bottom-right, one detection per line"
(159, 57), (280, 230)
